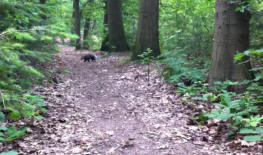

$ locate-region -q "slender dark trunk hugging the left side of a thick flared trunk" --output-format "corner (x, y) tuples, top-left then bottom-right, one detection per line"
(100, 0), (110, 51)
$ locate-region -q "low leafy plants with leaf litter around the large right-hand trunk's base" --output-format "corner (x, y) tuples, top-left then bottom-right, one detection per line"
(161, 47), (263, 150)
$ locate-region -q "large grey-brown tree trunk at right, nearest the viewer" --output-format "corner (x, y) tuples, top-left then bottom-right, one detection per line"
(209, 0), (253, 91)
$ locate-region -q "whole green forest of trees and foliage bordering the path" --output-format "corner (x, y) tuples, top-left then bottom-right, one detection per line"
(0, 0), (263, 154)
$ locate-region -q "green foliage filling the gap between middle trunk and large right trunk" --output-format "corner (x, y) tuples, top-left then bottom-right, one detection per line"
(160, 0), (216, 102)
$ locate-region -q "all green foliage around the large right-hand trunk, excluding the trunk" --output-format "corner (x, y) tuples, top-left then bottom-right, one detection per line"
(160, 0), (263, 141)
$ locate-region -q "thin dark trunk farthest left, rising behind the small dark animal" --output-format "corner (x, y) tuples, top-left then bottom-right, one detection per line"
(73, 0), (81, 50)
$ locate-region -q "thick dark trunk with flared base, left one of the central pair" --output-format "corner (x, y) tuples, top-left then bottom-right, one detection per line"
(107, 0), (129, 52)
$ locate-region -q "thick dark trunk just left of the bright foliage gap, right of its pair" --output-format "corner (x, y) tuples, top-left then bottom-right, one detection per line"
(132, 0), (161, 60)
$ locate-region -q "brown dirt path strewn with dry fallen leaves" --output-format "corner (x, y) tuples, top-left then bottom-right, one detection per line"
(0, 46), (260, 155)
